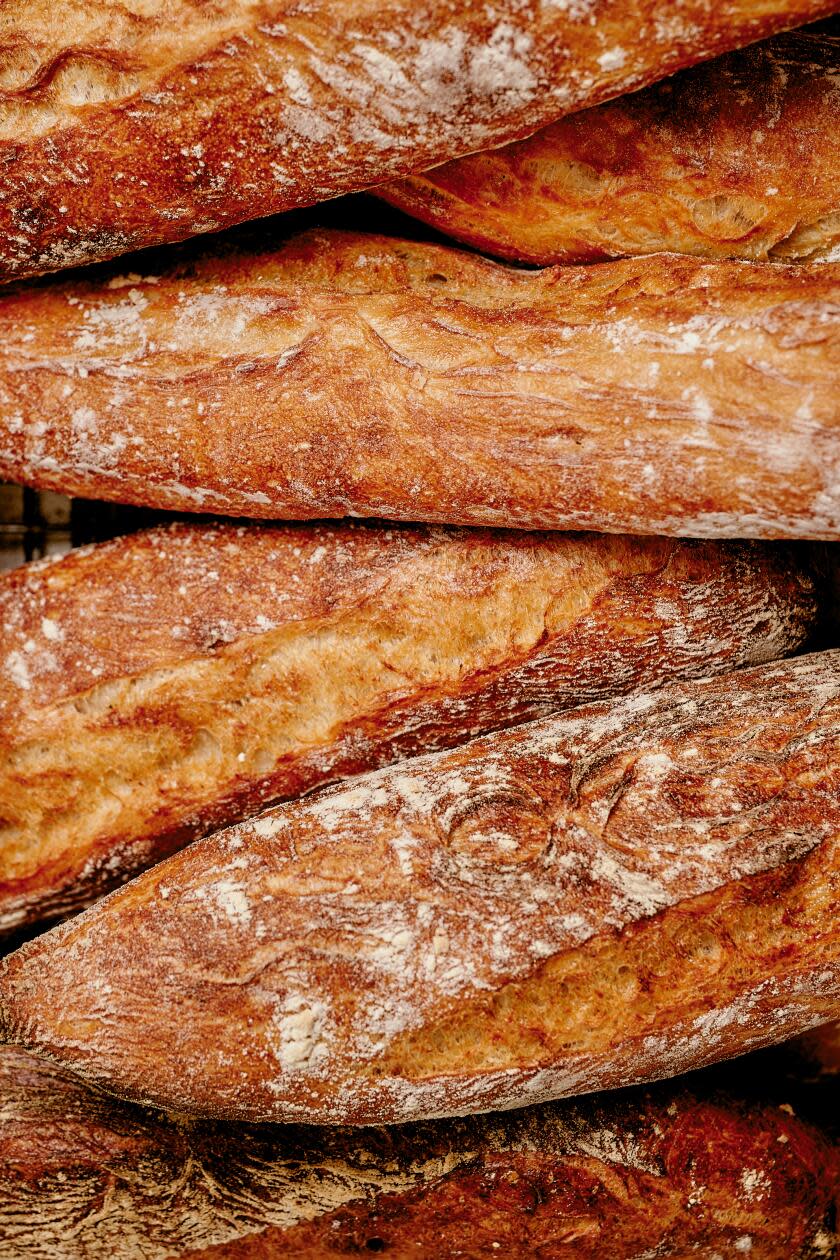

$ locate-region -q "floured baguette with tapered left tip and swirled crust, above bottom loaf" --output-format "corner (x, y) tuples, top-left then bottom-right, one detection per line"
(0, 650), (840, 1124)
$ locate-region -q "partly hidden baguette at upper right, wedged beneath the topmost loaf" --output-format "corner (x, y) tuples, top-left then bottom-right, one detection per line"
(377, 26), (840, 263)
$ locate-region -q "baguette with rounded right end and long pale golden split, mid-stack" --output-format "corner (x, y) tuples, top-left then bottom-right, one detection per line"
(0, 524), (819, 931)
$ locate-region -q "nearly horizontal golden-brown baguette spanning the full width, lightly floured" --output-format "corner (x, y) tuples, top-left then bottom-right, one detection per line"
(0, 232), (840, 539)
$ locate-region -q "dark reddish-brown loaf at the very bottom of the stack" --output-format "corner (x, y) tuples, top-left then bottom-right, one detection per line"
(0, 1047), (840, 1260)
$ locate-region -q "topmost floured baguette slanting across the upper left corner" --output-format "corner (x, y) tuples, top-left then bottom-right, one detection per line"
(0, 0), (836, 286)
